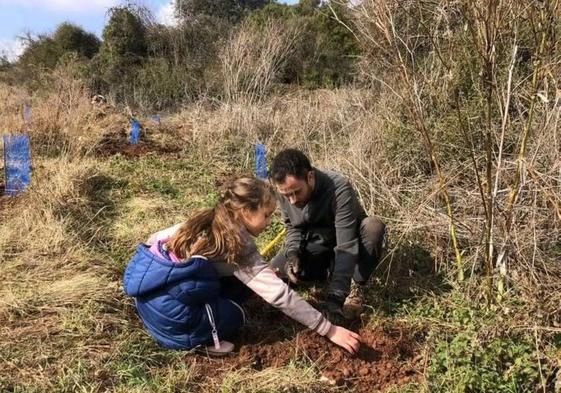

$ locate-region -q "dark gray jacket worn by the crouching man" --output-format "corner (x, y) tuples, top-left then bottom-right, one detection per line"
(280, 169), (366, 301)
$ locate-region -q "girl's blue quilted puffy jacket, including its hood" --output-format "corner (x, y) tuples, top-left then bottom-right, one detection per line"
(124, 244), (244, 349)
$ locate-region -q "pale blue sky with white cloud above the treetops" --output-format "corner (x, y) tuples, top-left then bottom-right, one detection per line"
(0, 0), (297, 61)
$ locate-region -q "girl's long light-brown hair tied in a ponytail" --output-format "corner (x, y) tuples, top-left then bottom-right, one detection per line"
(168, 176), (275, 263)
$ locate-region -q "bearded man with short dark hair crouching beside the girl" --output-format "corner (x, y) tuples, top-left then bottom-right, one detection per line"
(269, 149), (386, 319)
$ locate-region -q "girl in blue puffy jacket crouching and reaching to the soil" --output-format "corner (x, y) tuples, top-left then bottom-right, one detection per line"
(124, 177), (360, 355)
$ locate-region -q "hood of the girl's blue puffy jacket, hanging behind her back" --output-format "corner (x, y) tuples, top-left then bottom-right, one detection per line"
(123, 244), (216, 297)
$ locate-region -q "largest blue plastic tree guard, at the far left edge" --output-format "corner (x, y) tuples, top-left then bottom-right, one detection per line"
(2, 135), (31, 196)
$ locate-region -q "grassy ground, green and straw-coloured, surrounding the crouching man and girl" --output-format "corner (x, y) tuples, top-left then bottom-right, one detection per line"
(0, 83), (561, 392)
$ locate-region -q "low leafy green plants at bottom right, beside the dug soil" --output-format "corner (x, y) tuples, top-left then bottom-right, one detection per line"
(397, 288), (552, 393)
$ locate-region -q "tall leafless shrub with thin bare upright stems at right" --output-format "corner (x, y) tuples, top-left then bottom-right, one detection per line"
(342, 0), (561, 295)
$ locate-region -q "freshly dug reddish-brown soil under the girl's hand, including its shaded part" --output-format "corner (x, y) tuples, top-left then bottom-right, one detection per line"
(192, 298), (422, 392)
